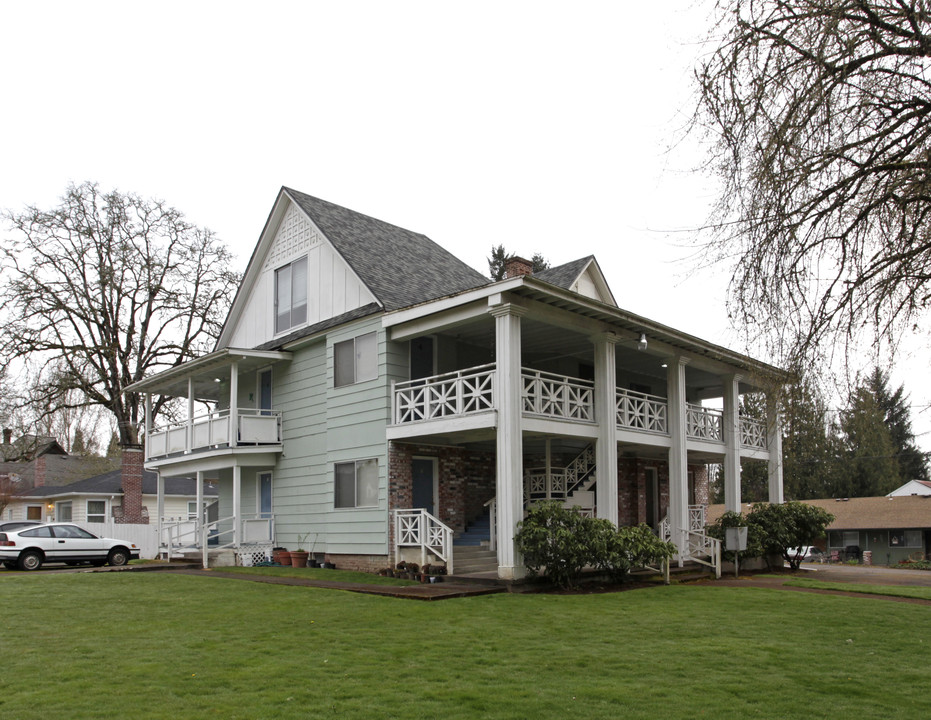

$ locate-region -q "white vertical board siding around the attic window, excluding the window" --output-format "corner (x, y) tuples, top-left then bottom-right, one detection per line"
(229, 201), (375, 347)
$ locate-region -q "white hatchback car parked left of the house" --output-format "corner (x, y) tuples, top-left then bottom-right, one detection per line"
(0, 523), (139, 570)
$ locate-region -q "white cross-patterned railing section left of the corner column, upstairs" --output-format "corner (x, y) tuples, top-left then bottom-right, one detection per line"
(393, 364), (495, 425)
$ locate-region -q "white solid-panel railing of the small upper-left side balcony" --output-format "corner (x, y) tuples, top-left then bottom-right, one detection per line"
(146, 409), (281, 458)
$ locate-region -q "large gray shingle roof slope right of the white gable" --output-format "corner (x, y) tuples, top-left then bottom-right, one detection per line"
(283, 187), (491, 310)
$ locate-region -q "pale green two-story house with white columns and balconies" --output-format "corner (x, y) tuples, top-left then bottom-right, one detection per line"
(127, 188), (785, 578)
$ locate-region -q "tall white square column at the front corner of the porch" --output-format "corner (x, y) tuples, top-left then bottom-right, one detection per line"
(489, 303), (526, 580)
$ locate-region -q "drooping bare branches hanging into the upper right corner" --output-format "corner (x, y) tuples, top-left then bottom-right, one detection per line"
(695, 0), (931, 364)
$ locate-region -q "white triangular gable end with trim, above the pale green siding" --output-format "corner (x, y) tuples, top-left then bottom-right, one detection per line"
(217, 192), (377, 349)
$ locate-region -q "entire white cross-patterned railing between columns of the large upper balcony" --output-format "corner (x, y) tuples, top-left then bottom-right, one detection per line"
(392, 363), (767, 452)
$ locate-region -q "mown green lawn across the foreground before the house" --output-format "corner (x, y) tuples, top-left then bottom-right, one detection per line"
(0, 572), (931, 720)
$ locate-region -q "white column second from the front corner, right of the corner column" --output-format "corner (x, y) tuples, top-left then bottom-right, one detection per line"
(592, 332), (618, 525)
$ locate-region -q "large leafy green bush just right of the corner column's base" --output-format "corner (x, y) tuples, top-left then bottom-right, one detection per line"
(515, 502), (675, 588)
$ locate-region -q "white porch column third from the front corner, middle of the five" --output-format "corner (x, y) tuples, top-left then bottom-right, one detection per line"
(666, 356), (689, 564)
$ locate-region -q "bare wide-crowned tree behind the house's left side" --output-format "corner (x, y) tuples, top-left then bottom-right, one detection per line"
(0, 182), (239, 443)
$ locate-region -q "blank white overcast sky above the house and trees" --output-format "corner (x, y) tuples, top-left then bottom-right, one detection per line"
(0, 0), (931, 447)
